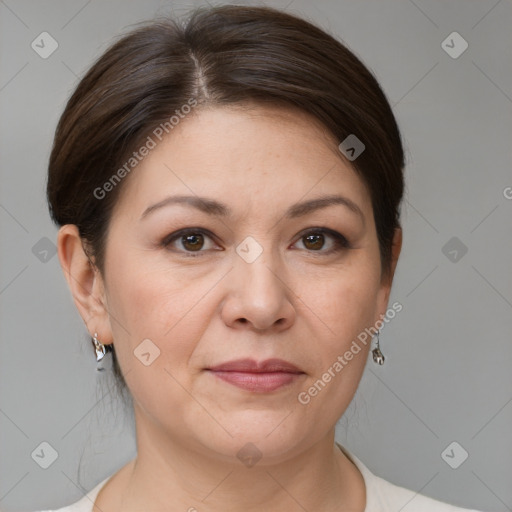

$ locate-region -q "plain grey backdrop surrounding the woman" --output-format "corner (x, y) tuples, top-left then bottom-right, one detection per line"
(0, 0), (512, 511)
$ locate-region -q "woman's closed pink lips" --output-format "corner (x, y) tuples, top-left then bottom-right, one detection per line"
(206, 359), (305, 393)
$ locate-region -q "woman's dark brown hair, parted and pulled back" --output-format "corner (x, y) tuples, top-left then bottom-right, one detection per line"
(47, 5), (405, 396)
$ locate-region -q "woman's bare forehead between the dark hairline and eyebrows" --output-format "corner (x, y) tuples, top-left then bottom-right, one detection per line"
(112, 106), (371, 222)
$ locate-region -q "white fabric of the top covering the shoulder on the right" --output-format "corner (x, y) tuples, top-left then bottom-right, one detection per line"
(337, 443), (482, 512)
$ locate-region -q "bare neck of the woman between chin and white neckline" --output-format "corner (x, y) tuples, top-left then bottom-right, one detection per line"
(114, 406), (366, 512)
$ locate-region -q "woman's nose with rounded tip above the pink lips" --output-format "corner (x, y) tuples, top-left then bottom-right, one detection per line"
(221, 243), (296, 333)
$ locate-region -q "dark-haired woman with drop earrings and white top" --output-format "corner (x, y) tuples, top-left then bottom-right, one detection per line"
(40, 6), (484, 512)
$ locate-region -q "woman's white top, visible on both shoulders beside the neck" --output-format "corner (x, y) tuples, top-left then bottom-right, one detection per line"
(35, 443), (482, 512)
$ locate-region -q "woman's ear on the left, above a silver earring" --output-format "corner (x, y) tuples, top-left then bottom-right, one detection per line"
(57, 224), (113, 345)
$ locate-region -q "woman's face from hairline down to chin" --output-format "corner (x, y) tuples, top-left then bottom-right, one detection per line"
(96, 107), (396, 464)
